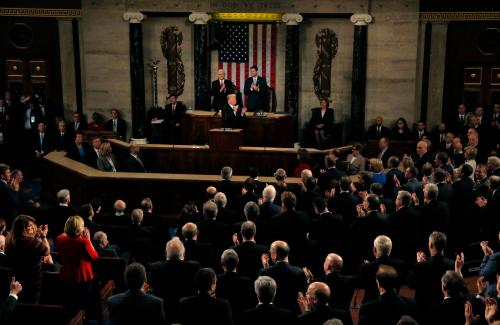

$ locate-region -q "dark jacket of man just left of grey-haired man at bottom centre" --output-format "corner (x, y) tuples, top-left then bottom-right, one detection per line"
(216, 272), (257, 316)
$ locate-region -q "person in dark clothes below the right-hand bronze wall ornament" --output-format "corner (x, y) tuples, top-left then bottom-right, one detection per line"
(309, 98), (335, 148)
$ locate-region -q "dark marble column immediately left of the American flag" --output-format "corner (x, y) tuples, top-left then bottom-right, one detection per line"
(189, 12), (210, 110)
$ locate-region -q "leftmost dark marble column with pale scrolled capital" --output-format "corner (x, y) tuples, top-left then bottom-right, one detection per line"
(123, 12), (146, 138)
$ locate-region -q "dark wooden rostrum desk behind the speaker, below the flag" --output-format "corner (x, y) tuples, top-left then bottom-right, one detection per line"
(182, 110), (293, 148)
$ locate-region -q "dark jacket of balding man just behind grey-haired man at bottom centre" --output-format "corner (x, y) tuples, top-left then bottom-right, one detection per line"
(259, 261), (307, 315)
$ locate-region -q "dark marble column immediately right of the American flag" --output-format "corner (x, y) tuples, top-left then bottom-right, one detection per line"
(282, 13), (303, 140)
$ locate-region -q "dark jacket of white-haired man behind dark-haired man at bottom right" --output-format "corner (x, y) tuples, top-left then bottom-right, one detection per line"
(356, 256), (406, 304)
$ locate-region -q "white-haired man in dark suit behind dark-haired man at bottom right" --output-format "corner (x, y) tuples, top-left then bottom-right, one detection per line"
(355, 236), (405, 303)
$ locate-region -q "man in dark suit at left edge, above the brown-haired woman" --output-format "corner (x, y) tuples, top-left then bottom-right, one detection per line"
(0, 164), (21, 224)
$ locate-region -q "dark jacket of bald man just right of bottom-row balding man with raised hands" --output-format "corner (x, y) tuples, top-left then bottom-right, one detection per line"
(318, 272), (354, 310)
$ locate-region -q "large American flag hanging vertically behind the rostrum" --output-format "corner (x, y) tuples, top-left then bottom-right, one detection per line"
(218, 23), (277, 93)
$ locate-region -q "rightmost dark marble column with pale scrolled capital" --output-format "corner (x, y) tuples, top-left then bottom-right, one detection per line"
(349, 14), (372, 139)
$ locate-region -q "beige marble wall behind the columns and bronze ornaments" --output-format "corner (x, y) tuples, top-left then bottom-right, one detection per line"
(77, 0), (422, 142)
